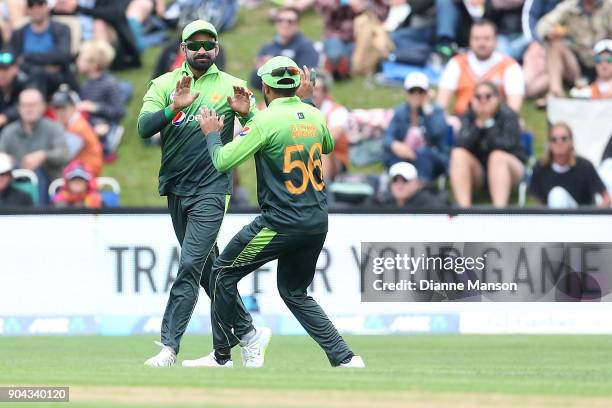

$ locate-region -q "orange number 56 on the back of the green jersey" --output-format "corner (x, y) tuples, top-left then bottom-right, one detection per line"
(283, 143), (325, 195)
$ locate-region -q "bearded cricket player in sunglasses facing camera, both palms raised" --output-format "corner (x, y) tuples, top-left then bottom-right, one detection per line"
(138, 20), (262, 367)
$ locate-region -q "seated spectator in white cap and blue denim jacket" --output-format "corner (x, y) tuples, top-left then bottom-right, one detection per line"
(384, 72), (449, 182)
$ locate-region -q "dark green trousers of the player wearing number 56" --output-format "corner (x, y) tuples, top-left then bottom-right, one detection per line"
(211, 217), (352, 366)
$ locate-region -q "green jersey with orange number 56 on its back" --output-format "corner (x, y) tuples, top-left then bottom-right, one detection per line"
(206, 97), (334, 234)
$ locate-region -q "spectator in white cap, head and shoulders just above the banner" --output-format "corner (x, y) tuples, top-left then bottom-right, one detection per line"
(381, 162), (449, 210)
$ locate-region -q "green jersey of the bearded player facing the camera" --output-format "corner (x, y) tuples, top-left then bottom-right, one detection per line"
(138, 62), (257, 196)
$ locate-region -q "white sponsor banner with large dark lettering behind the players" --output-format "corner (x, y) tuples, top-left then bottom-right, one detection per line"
(0, 214), (612, 334)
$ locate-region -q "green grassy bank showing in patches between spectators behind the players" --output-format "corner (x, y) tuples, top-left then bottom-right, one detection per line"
(104, 7), (546, 206)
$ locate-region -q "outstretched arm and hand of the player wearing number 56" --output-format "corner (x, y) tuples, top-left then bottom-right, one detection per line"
(200, 107), (263, 173)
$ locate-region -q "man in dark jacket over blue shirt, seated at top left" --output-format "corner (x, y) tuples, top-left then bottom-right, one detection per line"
(10, 0), (76, 97)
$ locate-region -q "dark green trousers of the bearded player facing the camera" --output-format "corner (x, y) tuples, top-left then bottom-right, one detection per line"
(161, 194), (253, 353)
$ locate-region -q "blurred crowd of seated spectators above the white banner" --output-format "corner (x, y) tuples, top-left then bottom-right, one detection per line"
(0, 0), (612, 209)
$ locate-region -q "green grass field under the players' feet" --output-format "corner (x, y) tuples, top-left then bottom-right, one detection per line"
(0, 335), (612, 408)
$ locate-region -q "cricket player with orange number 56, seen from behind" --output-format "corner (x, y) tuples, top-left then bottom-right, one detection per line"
(185, 57), (365, 368)
